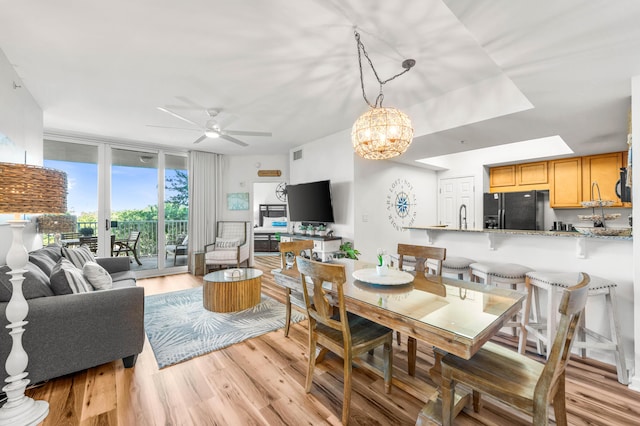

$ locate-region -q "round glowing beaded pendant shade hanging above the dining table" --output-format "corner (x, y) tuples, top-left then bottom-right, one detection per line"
(351, 107), (413, 160)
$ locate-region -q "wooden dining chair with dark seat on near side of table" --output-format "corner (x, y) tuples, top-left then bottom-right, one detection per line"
(296, 256), (393, 424)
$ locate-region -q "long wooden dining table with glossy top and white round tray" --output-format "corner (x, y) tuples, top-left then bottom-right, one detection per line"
(272, 259), (526, 425)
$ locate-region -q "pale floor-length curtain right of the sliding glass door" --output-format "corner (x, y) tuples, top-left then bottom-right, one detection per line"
(189, 151), (222, 257)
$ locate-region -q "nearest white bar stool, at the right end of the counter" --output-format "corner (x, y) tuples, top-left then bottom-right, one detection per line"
(518, 271), (629, 385)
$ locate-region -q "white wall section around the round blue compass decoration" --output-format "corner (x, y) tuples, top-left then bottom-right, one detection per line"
(354, 156), (437, 262)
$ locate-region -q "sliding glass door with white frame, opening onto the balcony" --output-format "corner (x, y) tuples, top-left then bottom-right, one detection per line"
(44, 140), (188, 277)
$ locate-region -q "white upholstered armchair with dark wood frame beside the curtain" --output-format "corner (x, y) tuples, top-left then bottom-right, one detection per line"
(204, 221), (251, 272)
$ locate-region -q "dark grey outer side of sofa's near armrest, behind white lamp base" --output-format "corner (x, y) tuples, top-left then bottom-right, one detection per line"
(0, 286), (144, 383)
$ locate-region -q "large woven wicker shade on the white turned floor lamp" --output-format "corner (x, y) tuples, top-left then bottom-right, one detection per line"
(0, 163), (67, 214)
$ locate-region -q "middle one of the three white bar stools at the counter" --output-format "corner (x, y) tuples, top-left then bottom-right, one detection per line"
(469, 262), (539, 336)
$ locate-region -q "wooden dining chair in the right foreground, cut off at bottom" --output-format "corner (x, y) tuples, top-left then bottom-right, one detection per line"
(442, 273), (590, 425)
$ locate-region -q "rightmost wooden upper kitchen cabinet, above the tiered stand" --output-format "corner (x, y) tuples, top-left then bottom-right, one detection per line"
(582, 152), (626, 207)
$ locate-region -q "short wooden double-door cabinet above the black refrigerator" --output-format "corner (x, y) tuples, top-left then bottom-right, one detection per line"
(489, 161), (549, 192)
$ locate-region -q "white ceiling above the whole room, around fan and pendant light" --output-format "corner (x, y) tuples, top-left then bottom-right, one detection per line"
(0, 0), (640, 163)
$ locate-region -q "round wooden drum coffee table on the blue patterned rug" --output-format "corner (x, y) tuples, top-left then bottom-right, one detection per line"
(202, 268), (262, 312)
